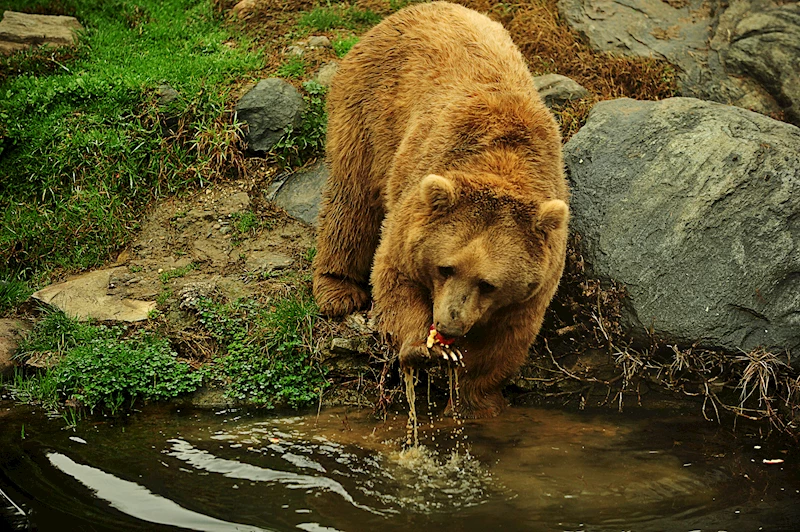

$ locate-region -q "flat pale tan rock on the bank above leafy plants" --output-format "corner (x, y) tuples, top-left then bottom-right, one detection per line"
(31, 267), (156, 322)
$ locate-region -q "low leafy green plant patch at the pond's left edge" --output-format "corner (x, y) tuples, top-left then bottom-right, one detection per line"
(6, 312), (203, 415)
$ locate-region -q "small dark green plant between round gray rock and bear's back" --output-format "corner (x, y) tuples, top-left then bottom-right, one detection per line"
(271, 81), (328, 166)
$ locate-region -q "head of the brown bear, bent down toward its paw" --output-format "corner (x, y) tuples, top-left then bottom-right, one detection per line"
(410, 174), (569, 337)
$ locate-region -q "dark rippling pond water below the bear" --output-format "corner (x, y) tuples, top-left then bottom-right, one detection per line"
(0, 403), (800, 531)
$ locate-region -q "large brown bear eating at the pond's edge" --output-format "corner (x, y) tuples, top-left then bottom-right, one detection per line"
(314, 2), (569, 417)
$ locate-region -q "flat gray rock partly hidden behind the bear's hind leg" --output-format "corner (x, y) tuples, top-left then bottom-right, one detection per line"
(269, 158), (328, 225)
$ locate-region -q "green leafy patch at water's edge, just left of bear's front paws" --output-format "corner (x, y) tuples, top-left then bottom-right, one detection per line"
(198, 291), (327, 408)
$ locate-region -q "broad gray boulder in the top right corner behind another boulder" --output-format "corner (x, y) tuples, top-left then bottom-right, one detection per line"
(558, 0), (800, 125)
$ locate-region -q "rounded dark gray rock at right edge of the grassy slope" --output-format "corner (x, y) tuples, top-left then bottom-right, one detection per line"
(236, 78), (305, 153)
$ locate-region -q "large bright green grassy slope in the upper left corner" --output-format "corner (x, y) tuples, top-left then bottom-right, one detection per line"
(0, 0), (263, 282)
